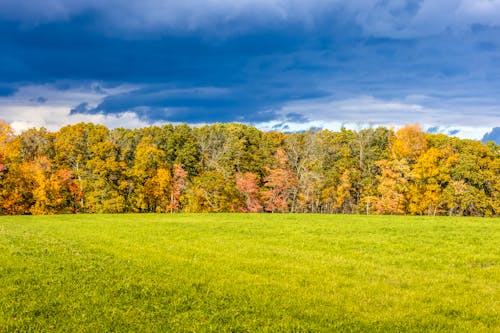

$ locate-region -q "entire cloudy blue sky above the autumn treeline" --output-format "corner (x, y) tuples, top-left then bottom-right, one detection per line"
(0, 0), (500, 143)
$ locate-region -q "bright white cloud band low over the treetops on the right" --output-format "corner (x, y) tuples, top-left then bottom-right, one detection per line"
(256, 95), (500, 140)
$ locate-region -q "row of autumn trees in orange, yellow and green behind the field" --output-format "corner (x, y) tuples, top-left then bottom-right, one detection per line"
(0, 122), (500, 216)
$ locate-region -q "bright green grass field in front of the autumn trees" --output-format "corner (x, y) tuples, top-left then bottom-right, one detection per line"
(0, 214), (500, 332)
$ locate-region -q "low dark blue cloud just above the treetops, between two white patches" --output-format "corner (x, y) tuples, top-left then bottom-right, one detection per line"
(81, 85), (322, 123)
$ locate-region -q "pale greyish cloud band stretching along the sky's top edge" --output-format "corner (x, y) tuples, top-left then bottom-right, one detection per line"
(0, 0), (500, 38)
